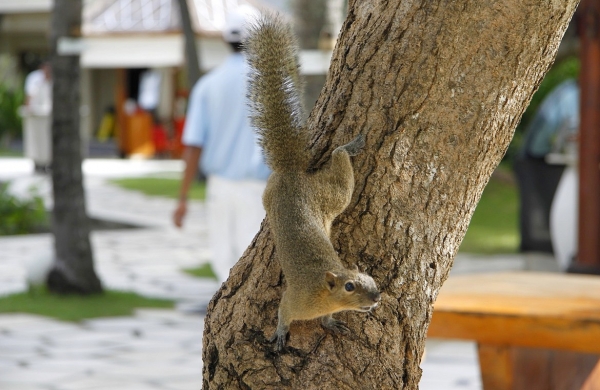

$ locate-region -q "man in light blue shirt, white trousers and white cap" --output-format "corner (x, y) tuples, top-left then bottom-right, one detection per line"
(173, 6), (271, 282)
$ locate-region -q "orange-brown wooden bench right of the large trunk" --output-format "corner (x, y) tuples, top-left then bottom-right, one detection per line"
(428, 272), (600, 390)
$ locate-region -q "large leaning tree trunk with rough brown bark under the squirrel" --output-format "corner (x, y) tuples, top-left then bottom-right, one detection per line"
(203, 0), (577, 389)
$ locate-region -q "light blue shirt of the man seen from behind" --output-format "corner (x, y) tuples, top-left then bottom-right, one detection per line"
(182, 53), (271, 180)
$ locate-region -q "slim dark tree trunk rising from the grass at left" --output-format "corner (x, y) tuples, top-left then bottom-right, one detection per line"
(48, 0), (102, 294)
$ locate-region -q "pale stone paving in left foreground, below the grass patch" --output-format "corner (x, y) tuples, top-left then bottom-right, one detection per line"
(0, 310), (203, 390)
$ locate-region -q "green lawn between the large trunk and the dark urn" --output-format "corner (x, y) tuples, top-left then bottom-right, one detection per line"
(460, 177), (520, 254)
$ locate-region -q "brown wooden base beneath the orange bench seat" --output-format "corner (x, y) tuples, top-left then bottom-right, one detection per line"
(478, 344), (600, 390)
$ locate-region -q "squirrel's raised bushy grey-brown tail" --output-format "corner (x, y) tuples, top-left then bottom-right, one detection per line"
(245, 16), (310, 172)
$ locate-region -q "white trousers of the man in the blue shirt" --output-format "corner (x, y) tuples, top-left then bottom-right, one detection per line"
(206, 176), (266, 283)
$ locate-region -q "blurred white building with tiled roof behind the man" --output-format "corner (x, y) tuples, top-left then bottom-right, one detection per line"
(0, 0), (324, 156)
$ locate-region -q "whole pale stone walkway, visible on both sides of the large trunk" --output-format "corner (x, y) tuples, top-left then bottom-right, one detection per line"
(0, 159), (552, 390)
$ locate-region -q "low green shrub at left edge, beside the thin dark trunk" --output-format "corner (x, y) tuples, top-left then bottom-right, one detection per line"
(0, 185), (48, 236)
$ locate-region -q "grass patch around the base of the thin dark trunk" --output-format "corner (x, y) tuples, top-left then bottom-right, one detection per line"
(0, 286), (174, 322)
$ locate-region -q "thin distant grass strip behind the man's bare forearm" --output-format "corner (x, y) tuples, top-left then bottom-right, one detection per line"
(111, 177), (206, 200)
